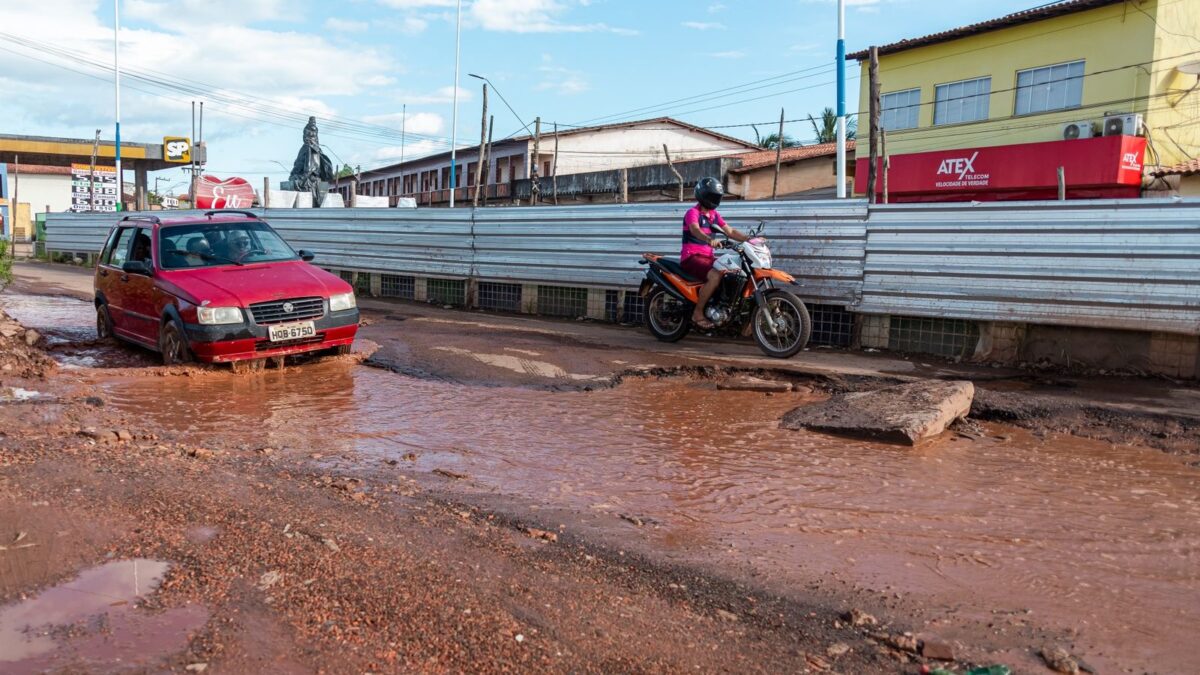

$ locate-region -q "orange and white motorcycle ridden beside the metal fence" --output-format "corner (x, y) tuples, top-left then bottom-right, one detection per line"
(638, 222), (812, 358)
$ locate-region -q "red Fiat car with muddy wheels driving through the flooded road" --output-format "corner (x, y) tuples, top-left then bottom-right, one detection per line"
(95, 210), (359, 364)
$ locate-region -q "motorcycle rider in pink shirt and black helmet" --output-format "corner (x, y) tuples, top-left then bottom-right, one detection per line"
(679, 177), (749, 329)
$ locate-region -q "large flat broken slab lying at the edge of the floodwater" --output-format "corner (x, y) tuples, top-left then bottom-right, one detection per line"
(782, 380), (974, 446)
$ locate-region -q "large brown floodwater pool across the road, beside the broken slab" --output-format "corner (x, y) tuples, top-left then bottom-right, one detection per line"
(7, 291), (1200, 673)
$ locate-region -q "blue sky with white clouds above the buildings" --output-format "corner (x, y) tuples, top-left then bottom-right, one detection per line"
(0, 0), (1034, 189)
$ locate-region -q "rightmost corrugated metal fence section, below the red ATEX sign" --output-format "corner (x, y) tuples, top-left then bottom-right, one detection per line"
(856, 199), (1200, 334)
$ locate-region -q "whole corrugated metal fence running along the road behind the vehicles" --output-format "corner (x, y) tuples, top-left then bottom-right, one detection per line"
(37, 199), (1200, 335)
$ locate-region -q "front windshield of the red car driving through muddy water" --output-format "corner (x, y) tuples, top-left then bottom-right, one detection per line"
(158, 221), (299, 269)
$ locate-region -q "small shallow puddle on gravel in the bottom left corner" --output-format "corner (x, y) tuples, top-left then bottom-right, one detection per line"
(0, 558), (208, 675)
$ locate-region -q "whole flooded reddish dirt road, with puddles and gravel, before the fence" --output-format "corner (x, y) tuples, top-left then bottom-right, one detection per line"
(7, 260), (1200, 673)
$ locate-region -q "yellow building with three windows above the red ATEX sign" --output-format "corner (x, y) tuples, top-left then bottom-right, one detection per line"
(850, 0), (1200, 196)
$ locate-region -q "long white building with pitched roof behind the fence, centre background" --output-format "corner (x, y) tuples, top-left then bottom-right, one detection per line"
(336, 118), (760, 205)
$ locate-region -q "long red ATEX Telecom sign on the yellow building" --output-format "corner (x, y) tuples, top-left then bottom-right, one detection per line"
(854, 136), (1146, 202)
